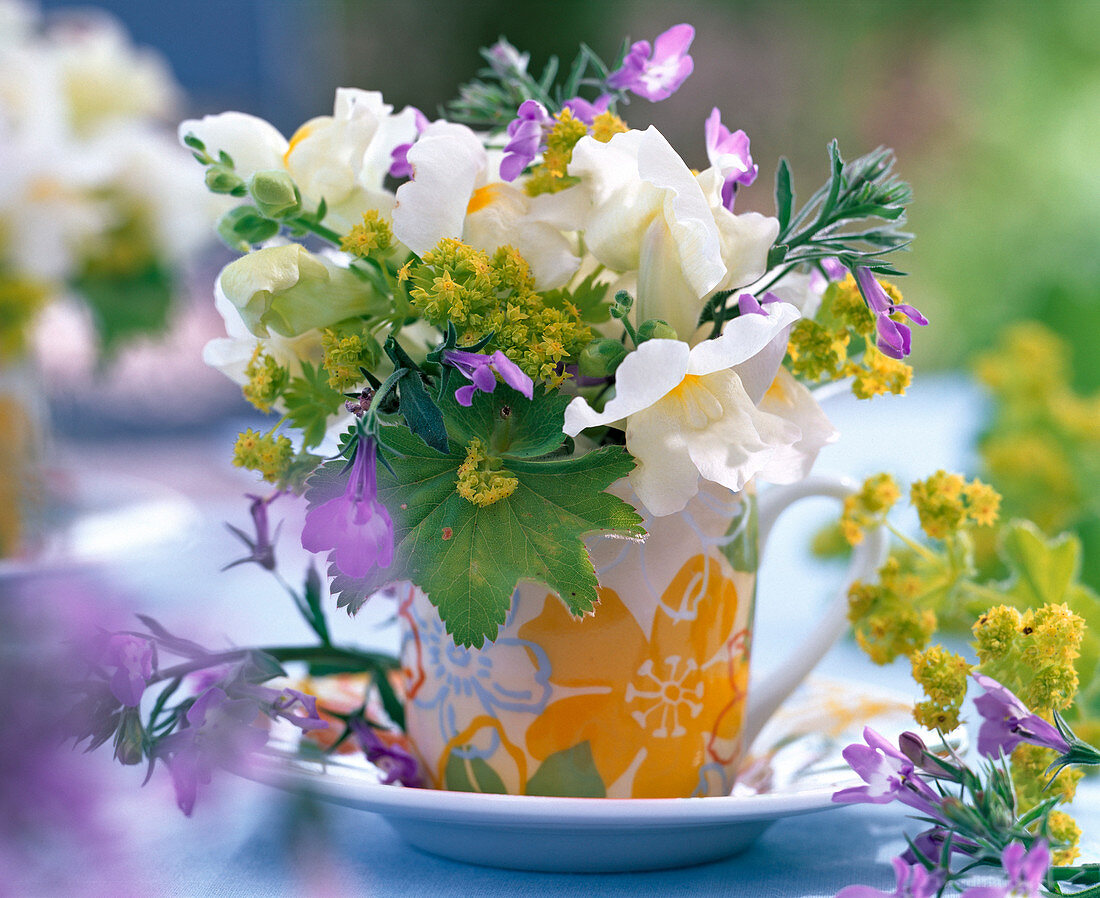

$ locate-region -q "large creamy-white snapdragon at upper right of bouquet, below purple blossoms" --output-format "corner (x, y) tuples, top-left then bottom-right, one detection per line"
(564, 128), (779, 342)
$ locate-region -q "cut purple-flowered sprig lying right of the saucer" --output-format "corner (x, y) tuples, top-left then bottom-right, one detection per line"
(833, 674), (1100, 898)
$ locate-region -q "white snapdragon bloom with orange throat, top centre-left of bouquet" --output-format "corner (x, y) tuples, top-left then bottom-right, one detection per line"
(394, 121), (580, 289)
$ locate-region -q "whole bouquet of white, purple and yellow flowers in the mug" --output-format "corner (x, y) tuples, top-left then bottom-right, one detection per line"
(179, 24), (926, 647)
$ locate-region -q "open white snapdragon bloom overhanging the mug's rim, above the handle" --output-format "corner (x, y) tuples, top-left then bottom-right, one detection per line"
(564, 303), (833, 515)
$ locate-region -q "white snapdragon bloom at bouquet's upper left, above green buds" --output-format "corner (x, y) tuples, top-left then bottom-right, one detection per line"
(179, 88), (416, 230)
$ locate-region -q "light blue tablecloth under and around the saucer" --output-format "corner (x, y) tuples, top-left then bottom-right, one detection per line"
(17, 379), (1100, 898)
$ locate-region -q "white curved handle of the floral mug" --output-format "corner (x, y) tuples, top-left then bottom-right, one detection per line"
(743, 474), (889, 749)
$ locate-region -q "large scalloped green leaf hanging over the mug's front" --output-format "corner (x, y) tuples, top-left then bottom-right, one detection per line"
(307, 385), (645, 647)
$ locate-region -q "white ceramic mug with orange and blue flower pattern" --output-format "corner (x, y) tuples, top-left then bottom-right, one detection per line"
(398, 477), (886, 798)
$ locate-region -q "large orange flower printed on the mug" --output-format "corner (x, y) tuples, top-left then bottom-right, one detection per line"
(520, 555), (747, 798)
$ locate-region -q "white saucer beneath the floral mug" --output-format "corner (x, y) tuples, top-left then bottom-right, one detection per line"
(249, 679), (954, 873)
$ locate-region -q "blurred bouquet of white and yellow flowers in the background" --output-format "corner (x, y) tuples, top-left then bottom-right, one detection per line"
(0, 0), (219, 364)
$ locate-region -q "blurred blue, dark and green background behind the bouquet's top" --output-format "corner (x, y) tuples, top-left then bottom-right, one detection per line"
(43, 0), (1100, 378)
